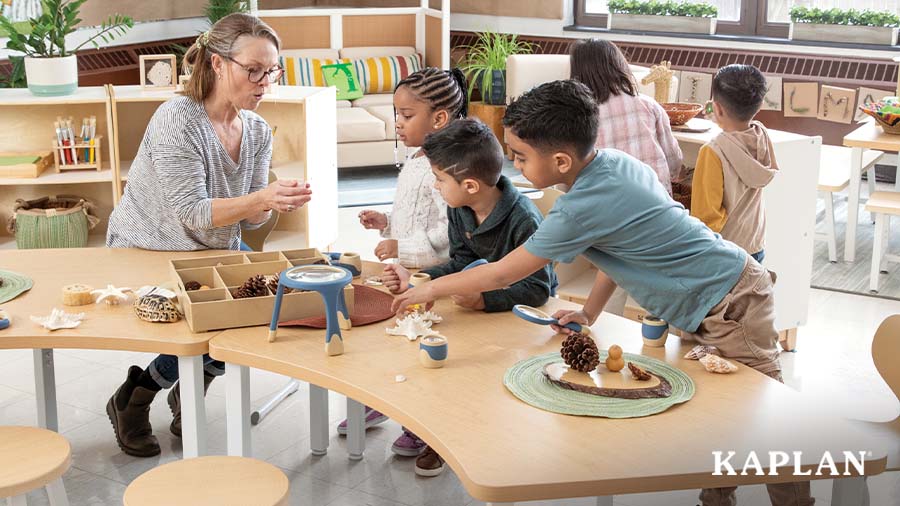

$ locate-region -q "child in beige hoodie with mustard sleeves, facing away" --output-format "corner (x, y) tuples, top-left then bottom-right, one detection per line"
(691, 64), (778, 263)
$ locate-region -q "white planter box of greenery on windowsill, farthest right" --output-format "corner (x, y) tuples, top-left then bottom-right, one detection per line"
(789, 5), (900, 46)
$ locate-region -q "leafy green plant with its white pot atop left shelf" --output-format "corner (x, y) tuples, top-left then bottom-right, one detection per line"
(0, 0), (134, 96)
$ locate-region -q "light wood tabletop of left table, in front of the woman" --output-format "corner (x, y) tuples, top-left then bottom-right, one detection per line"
(0, 248), (229, 356)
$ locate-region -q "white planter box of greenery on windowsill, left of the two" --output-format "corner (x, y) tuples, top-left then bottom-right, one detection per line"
(607, 0), (719, 35)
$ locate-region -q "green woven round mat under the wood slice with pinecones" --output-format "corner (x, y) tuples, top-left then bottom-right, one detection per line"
(503, 351), (694, 418)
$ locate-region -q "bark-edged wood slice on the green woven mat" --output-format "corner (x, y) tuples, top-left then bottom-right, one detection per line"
(543, 362), (672, 399)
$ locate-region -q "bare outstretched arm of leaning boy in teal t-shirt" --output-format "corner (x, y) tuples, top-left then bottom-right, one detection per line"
(393, 246), (552, 312)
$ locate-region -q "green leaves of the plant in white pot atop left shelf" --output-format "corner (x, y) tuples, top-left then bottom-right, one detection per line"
(0, 0), (134, 58)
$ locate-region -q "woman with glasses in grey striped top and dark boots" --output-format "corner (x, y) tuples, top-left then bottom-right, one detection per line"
(106, 14), (312, 457)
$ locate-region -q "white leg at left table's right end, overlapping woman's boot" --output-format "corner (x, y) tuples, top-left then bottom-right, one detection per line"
(178, 355), (206, 459)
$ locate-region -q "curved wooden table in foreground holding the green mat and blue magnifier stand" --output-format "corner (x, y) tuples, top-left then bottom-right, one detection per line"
(210, 263), (886, 504)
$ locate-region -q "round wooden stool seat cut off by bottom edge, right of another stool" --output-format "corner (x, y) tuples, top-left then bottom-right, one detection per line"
(124, 456), (289, 506)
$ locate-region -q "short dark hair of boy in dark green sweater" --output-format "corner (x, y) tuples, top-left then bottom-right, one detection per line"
(422, 119), (503, 186)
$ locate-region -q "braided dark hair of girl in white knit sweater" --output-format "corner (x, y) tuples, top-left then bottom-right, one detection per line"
(394, 67), (469, 119)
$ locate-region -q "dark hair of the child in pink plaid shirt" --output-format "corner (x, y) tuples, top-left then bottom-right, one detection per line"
(569, 39), (637, 104)
